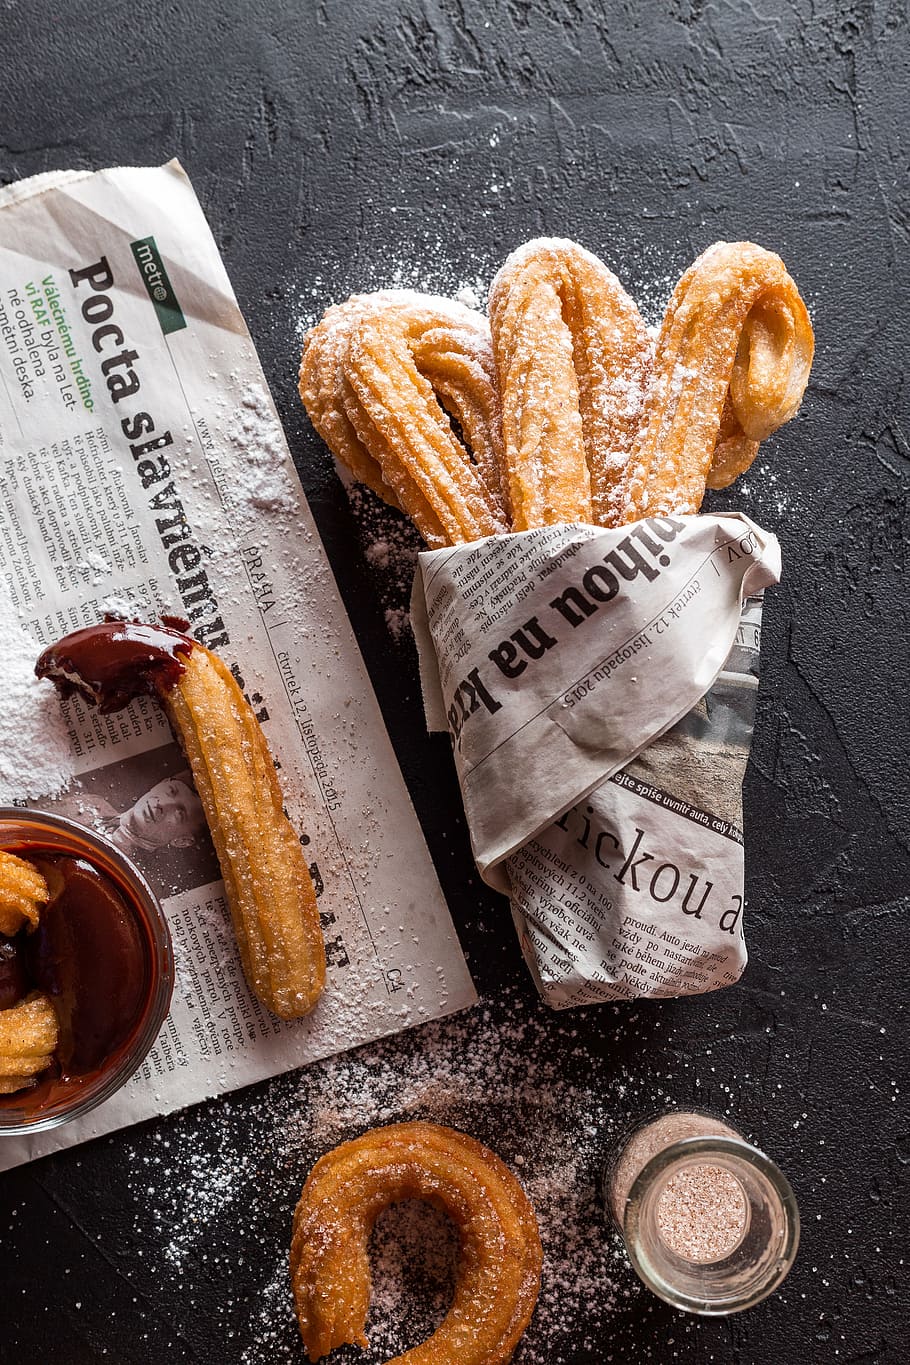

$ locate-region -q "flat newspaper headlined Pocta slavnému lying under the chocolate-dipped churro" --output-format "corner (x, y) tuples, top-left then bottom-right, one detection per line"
(0, 161), (476, 1168)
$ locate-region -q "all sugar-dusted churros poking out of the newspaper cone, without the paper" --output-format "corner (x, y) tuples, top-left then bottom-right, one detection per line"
(300, 239), (813, 549)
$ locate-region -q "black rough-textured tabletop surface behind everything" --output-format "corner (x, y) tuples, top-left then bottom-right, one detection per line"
(0, 0), (910, 1365)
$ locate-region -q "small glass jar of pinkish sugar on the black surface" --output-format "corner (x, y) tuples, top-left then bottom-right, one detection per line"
(603, 1111), (799, 1314)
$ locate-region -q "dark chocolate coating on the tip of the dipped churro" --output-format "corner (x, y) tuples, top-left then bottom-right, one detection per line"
(35, 617), (194, 711)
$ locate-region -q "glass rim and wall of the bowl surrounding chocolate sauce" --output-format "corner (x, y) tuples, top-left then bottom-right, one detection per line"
(0, 807), (175, 1140)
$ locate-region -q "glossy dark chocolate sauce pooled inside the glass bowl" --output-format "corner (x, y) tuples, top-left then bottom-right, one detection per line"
(25, 853), (146, 1080)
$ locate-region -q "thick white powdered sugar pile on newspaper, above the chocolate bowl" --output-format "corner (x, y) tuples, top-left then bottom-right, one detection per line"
(0, 591), (74, 804)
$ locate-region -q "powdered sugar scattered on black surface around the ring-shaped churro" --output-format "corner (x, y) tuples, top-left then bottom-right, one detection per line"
(122, 988), (663, 1365)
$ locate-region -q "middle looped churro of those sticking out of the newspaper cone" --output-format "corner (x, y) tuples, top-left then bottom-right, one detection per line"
(490, 238), (652, 531)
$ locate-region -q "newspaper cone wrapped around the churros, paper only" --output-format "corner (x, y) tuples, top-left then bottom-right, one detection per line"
(412, 515), (780, 1009)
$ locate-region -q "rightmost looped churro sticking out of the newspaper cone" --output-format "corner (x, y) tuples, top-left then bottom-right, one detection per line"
(621, 242), (814, 523)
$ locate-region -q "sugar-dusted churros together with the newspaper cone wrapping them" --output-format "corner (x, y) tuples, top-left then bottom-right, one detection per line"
(300, 240), (813, 1007)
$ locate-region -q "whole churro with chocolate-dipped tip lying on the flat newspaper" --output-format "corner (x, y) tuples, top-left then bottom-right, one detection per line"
(35, 621), (326, 1018)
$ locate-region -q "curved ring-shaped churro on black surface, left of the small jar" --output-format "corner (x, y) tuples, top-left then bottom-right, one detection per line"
(291, 1122), (542, 1365)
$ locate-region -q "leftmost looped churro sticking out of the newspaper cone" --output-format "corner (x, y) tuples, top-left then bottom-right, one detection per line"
(300, 291), (508, 547)
